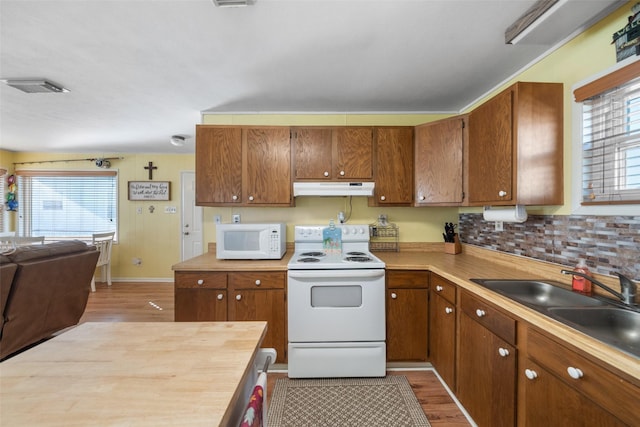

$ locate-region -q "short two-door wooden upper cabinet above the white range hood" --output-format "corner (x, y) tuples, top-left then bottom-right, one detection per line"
(291, 126), (373, 181)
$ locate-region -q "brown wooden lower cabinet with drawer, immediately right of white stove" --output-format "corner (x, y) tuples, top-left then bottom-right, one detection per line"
(386, 270), (429, 362)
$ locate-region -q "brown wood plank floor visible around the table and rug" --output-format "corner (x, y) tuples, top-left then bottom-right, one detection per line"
(80, 282), (470, 427)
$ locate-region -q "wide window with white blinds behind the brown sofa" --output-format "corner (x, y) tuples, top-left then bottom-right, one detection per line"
(16, 171), (118, 240)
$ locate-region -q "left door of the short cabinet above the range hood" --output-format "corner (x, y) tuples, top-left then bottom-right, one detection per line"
(291, 128), (332, 180)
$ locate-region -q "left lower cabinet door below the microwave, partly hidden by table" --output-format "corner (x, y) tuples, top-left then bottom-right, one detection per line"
(174, 288), (227, 322)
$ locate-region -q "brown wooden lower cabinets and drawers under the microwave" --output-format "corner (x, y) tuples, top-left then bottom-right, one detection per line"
(175, 272), (287, 363)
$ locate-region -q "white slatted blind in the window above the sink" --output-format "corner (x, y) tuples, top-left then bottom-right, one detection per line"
(582, 78), (640, 205)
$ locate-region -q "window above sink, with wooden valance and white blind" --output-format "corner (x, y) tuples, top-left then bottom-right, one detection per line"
(573, 61), (640, 213)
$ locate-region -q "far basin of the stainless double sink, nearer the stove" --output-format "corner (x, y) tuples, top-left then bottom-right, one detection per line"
(471, 279), (606, 309)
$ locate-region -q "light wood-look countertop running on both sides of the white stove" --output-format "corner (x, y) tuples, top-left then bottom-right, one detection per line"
(173, 245), (640, 386)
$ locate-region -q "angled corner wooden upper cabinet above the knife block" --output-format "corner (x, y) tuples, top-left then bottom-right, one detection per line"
(414, 116), (468, 206)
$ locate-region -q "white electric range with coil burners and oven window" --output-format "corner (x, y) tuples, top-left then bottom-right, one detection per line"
(287, 224), (386, 378)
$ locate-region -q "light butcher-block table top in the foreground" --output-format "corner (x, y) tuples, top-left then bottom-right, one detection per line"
(0, 322), (266, 426)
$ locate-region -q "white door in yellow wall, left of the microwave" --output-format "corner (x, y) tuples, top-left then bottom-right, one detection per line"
(180, 172), (204, 261)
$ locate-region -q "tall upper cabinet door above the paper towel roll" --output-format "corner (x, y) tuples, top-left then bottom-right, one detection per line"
(469, 90), (515, 204)
